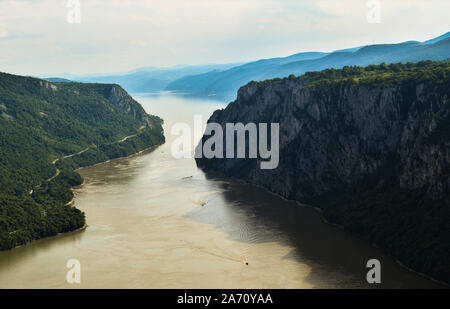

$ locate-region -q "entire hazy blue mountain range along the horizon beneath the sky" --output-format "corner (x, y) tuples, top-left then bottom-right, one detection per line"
(47, 32), (450, 101)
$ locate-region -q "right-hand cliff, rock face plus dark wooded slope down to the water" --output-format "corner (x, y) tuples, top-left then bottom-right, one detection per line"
(197, 62), (450, 281)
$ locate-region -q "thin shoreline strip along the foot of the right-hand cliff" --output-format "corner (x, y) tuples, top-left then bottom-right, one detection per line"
(203, 167), (450, 288)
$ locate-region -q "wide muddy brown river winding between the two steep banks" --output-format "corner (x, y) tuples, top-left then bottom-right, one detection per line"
(0, 93), (439, 288)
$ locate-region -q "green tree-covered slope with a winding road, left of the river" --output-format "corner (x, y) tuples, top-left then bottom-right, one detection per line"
(0, 73), (164, 249)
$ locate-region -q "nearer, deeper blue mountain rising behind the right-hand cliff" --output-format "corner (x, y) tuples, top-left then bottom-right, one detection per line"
(166, 33), (450, 100)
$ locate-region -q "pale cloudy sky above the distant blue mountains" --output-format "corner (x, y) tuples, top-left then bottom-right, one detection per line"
(0, 0), (450, 76)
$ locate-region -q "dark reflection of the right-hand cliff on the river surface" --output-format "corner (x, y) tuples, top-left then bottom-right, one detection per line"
(187, 173), (440, 288)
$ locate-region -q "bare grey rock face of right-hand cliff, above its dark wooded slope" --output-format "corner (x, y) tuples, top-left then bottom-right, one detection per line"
(197, 74), (450, 201)
